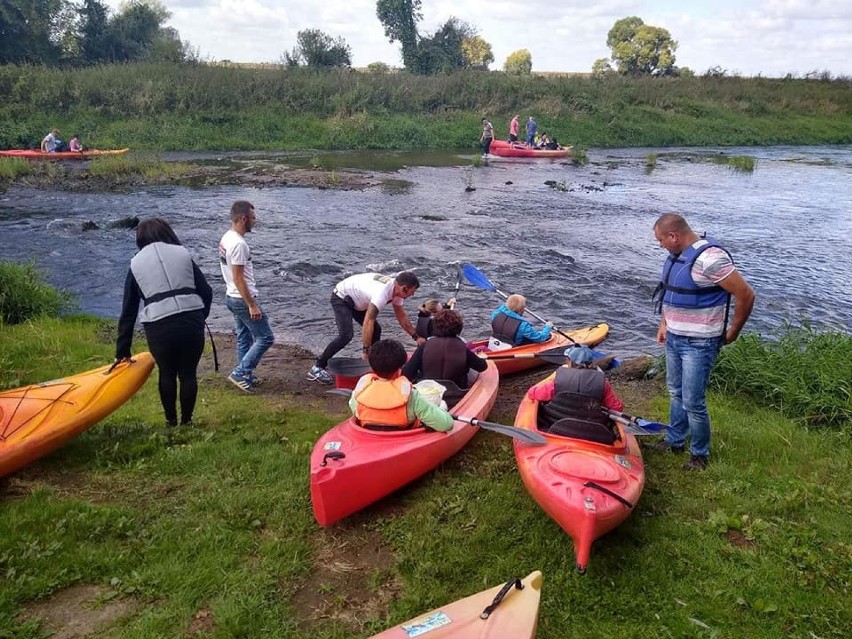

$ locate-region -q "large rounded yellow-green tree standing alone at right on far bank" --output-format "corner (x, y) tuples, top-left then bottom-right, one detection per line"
(606, 16), (677, 75)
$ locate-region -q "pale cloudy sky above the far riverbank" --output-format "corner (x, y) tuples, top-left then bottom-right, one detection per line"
(106, 0), (852, 77)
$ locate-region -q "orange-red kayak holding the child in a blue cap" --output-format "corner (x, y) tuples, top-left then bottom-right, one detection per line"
(515, 375), (645, 573)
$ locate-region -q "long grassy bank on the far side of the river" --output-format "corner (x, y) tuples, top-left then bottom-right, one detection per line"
(0, 65), (852, 151)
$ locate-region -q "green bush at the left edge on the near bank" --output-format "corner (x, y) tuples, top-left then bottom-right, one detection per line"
(0, 261), (72, 325)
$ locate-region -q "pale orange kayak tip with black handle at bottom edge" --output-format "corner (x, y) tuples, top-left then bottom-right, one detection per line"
(371, 570), (542, 639)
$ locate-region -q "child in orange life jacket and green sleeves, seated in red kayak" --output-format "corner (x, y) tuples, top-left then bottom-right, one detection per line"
(349, 339), (453, 431)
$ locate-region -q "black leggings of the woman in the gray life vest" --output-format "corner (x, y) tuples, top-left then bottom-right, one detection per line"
(144, 311), (204, 424)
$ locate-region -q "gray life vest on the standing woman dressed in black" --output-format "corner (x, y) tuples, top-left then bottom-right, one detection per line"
(130, 242), (204, 322)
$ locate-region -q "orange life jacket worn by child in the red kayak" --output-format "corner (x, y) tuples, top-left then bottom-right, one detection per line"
(352, 373), (420, 430)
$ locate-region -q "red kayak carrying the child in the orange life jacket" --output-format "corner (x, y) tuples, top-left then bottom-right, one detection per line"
(311, 363), (500, 526)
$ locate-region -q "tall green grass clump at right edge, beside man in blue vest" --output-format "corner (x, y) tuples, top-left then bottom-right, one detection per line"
(711, 326), (852, 426)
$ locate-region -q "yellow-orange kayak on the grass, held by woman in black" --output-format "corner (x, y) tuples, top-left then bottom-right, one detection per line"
(0, 353), (154, 477)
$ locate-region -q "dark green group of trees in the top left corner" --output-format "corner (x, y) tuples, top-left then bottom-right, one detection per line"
(0, 0), (198, 66)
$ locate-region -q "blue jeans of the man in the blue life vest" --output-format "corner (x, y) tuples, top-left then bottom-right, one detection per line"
(666, 332), (722, 457)
